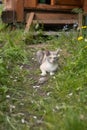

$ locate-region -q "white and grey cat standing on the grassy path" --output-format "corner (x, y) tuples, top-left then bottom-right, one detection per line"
(36, 49), (60, 76)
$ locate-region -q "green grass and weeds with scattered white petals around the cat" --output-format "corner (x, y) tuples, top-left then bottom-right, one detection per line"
(0, 5), (87, 130)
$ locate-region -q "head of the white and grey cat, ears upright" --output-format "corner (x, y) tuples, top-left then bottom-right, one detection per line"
(46, 49), (60, 63)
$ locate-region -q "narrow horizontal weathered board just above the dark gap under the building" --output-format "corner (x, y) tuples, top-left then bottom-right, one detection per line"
(33, 19), (78, 24)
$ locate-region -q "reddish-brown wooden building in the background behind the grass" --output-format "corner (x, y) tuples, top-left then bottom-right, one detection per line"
(1, 0), (87, 26)
